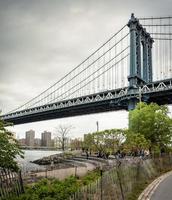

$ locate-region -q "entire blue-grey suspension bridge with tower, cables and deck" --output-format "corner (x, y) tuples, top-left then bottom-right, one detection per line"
(1, 14), (172, 124)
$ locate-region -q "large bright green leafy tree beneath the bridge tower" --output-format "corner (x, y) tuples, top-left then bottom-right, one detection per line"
(129, 103), (172, 150)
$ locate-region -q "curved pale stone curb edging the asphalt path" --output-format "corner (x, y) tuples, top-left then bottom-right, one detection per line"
(138, 171), (172, 200)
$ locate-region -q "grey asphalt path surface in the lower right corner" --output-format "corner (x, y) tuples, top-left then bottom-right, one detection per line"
(151, 175), (172, 200)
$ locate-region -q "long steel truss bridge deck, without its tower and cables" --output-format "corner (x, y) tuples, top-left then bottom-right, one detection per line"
(0, 79), (172, 125)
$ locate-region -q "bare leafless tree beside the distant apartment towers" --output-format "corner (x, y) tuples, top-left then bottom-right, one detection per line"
(54, 125), (73, 151)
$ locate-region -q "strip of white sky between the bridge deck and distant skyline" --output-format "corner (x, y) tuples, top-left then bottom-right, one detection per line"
(12, 111), (128, 138)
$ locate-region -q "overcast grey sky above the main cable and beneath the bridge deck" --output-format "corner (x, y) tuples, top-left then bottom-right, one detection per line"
(0, 0), (172, 137)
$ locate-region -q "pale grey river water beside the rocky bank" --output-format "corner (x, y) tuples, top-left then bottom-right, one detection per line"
(17, 150), (61, 172)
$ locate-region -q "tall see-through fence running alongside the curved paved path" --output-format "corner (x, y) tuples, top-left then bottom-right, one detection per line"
(70, 157), (172, 200)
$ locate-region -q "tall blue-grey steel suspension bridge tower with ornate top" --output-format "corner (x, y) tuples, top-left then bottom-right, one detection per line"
(127, 13), (154, 110)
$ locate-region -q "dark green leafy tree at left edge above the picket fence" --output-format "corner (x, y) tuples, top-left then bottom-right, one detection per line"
(0, 119), (23, 171)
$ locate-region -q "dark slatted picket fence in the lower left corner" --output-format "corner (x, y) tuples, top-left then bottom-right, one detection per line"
(0, 168), (24, 200)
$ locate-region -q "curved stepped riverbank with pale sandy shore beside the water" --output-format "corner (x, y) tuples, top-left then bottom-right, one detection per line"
(23, 152), (109, 183)
